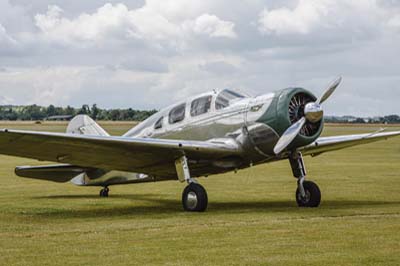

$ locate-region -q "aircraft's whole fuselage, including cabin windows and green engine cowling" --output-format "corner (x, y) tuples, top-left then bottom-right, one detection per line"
(79, 88), (323, 187)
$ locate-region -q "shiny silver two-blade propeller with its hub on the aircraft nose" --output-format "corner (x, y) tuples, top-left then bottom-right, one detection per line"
(274, 77), (342, 154)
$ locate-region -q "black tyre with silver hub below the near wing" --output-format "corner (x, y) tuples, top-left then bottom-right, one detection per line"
(182, 183), (208, 212)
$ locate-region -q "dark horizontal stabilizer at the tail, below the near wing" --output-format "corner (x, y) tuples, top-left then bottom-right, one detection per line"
(15, 164), (87, 183)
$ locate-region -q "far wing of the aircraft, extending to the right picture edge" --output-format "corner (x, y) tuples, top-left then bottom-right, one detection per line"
(299, 131), (400, 156)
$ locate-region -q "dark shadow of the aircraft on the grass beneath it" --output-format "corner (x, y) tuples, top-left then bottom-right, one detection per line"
(30, 194), (400, 219)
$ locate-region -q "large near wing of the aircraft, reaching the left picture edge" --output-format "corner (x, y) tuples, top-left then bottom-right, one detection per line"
(0, 129), (241, 177)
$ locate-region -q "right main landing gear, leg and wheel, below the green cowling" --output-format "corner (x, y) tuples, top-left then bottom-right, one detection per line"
(289, 152), (321, 208)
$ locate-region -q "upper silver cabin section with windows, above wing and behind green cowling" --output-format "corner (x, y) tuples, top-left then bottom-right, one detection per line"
(124, 90), (275, 141)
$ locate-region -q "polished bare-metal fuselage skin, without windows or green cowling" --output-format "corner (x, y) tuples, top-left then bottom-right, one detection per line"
(77, 90), (279, 185)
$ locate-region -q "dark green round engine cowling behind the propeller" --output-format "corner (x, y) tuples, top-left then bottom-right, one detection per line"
(257, 88), (324, 153)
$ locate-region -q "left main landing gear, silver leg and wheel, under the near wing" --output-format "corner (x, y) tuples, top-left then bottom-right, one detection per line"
(175, 156), (208, 212)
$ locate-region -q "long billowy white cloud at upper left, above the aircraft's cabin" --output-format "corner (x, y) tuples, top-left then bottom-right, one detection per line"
(35, 1), (236, 48)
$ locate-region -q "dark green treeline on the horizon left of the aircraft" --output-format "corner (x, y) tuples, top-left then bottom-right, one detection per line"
(0, 104), (157, 121)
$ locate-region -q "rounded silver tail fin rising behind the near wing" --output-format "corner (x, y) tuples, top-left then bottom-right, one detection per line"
(67, 115), (110, 136)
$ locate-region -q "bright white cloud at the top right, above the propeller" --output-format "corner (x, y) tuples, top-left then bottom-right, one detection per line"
(258, 0), (391, 35)
